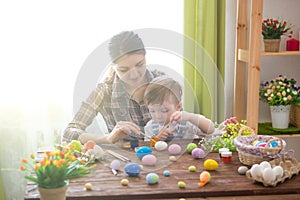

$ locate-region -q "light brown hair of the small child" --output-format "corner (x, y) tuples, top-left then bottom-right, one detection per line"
(144, 76), (182, 105)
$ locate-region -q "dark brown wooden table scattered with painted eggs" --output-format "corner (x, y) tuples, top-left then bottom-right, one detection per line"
(25, 142), (300, 200)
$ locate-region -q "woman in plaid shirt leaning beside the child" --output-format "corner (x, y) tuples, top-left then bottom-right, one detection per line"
(62, 31), (163, 143)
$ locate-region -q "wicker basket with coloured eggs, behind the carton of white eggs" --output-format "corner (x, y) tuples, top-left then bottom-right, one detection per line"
(234, 127), (286, 166)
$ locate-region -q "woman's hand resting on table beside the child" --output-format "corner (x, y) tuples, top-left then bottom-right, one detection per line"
(107, 121), (141, 143)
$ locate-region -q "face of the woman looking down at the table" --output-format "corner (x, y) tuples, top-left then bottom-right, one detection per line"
(114, 53), (146, 86)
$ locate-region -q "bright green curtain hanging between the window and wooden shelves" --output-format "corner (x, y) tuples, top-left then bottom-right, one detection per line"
(184, 0), (226, 122)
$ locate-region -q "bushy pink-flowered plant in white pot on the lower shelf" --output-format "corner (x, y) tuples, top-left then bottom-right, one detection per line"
(259, 75), (299, 129)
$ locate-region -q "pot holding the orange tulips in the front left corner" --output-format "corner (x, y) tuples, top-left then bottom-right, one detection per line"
(38, 186), (68, 200)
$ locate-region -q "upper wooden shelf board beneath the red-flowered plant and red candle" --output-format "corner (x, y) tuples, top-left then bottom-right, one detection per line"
(238, 49), (300, 62)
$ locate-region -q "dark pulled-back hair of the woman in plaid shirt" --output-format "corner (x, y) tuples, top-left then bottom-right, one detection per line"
(108, 31), (146, 62)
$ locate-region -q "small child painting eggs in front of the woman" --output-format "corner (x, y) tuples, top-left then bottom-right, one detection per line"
(144, 76), (215, 140)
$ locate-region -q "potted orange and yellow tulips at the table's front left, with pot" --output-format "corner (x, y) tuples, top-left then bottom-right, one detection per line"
(20, 141), (92, 200)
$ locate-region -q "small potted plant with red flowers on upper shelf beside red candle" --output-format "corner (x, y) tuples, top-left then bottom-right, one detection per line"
(262, 18), (292, 52)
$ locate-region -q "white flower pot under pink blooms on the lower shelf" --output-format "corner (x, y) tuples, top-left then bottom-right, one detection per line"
(270, 105), (291, 129)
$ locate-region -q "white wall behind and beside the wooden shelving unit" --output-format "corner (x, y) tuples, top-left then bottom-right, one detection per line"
(225, 0), (300, 122)
